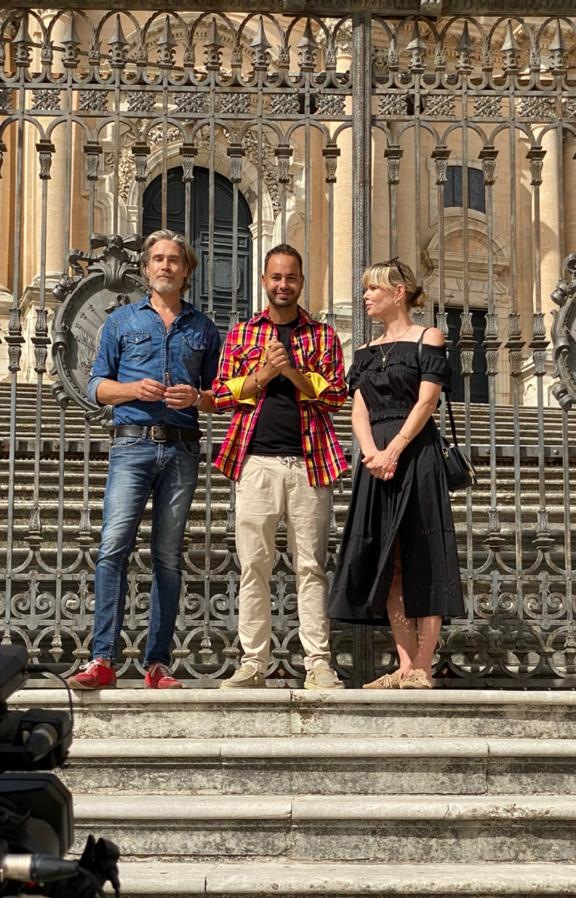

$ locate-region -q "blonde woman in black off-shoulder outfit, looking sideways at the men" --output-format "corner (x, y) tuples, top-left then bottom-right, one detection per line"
(329, 258), (464, 689)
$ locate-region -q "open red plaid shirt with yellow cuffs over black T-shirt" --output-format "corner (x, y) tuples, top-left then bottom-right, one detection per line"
(213, 306), (348, 486)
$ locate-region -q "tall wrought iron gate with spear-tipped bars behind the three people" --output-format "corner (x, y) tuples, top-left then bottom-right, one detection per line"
(0, 3), (576, 685)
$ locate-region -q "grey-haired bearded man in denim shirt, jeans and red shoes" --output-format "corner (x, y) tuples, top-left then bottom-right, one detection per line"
(68, 231), (220, 689)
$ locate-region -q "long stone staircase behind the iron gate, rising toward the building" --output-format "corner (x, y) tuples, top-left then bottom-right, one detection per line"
(0, 384), (576, 686)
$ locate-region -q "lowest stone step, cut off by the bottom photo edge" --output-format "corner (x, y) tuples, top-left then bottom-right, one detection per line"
(101, 861), (576, 898)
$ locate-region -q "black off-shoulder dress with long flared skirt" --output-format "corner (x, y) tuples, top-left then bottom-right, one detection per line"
(328, 341), (464, 624)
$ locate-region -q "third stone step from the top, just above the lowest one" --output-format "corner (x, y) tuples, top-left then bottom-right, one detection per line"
(68, 794), (576, 864)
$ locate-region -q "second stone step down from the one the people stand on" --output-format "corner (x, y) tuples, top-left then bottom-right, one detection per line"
(60, 736), (576, 795)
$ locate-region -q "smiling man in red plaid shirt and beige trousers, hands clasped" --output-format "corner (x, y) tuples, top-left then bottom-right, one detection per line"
(213, 244), (347, 689)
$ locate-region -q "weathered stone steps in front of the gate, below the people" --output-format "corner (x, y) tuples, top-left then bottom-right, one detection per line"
(14, 688), (576, 898)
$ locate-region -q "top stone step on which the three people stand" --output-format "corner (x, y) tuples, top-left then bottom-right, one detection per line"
(10, 680), (576, 740)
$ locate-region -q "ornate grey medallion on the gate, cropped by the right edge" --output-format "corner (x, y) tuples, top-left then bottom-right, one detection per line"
(551, 253), (576, 411)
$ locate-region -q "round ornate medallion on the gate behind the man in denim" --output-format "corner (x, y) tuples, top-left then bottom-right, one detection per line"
(52, 234), (146, 412)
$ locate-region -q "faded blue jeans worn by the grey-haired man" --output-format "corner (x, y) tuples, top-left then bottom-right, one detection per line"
(92, 437), (199, 667)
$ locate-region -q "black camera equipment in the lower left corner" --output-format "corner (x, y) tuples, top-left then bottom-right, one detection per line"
(0, 646), (120, 898)
